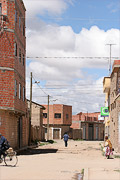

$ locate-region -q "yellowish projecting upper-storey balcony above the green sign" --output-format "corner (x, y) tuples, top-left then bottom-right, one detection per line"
(103, 77), (111, 93)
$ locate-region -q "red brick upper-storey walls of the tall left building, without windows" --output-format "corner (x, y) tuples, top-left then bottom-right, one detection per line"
(0, 0), (26, 112)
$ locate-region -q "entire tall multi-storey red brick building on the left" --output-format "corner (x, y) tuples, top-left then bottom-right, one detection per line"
(0, 0), (29, 148)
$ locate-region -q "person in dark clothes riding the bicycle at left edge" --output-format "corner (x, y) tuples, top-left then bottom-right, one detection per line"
(0, 133), (10, 160)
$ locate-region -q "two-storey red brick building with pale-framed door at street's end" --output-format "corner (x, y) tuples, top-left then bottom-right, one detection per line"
(43, 104), (72, 139)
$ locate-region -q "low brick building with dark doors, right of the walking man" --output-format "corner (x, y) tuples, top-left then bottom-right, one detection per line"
(71, 112), (104, 140)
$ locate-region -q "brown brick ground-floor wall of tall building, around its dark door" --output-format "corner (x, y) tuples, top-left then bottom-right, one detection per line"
(0, 110), (29, 149)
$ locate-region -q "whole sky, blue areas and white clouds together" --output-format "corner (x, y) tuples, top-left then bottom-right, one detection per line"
(24, 0), (120, 114)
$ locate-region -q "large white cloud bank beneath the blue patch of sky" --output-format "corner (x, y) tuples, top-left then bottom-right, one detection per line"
(27, 23), (120, 113)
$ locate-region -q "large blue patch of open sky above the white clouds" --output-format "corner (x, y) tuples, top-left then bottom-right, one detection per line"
(37, 0), (120, 33)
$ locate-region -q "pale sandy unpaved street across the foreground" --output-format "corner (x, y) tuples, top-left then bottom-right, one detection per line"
(0, 140), (120, 180)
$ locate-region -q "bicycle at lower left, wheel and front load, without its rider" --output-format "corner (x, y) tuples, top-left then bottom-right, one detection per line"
(0, 150), (18, 167)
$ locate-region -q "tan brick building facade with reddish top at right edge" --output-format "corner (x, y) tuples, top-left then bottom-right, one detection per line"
(109, 60), (120, 152)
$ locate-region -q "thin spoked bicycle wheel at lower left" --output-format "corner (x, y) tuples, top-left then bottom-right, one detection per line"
(4, 154), (18, 167)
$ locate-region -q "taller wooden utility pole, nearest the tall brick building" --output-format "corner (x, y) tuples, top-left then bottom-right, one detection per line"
(29, 72), (32, 145)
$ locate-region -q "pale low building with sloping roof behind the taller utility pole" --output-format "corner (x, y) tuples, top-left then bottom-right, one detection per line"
(27, 100), (45, 141)
